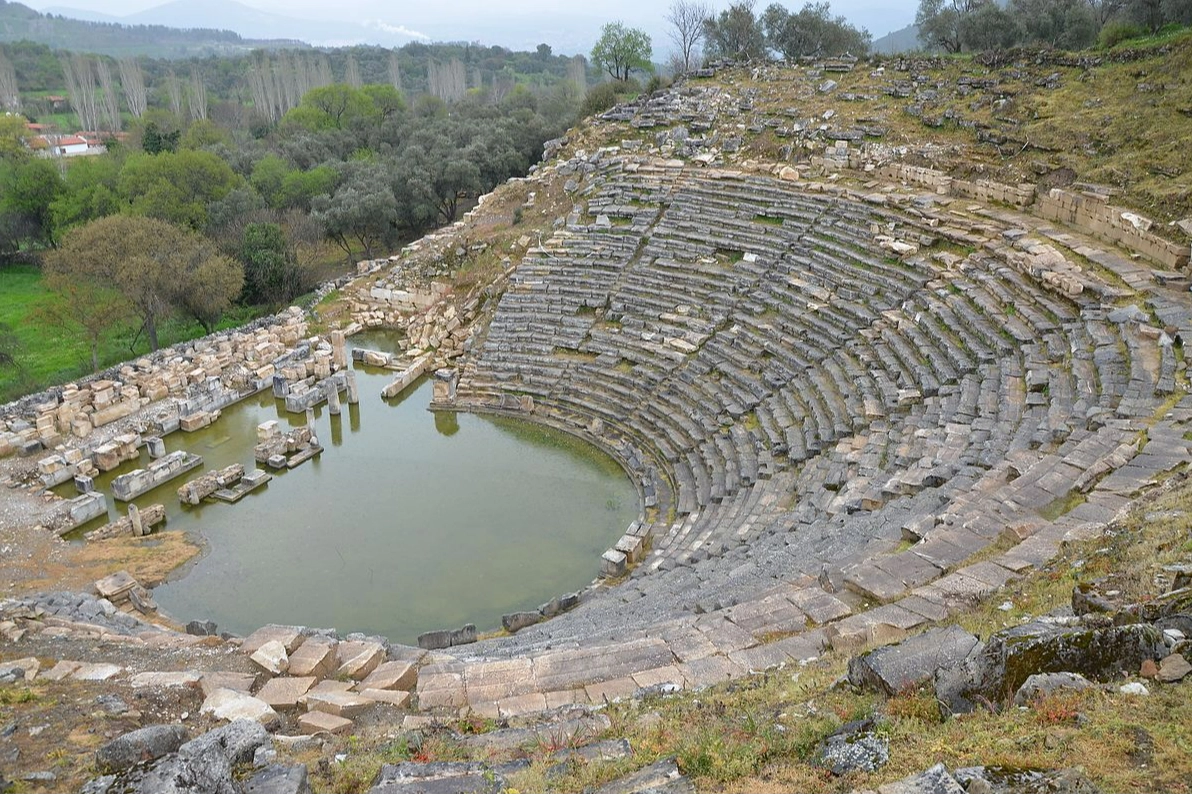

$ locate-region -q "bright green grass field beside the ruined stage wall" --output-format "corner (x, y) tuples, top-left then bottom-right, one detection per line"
(0, 265), (254, 402)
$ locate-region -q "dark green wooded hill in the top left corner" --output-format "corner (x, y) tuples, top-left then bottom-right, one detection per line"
(0, 0), (305, 58)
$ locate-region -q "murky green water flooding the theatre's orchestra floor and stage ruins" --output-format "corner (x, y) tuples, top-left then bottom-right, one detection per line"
(63, 337), (638, 642)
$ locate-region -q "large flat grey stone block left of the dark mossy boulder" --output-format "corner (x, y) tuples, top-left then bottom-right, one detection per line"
(849, 626), (979, 696)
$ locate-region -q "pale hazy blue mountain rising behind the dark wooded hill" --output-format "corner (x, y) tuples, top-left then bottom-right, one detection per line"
(46, 0), (426, 46)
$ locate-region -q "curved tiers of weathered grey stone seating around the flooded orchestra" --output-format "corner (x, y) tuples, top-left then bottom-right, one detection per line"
(448, 163), (1192, 678)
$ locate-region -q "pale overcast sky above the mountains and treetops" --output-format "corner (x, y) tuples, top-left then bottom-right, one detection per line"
(23, 0), (918, 52)
